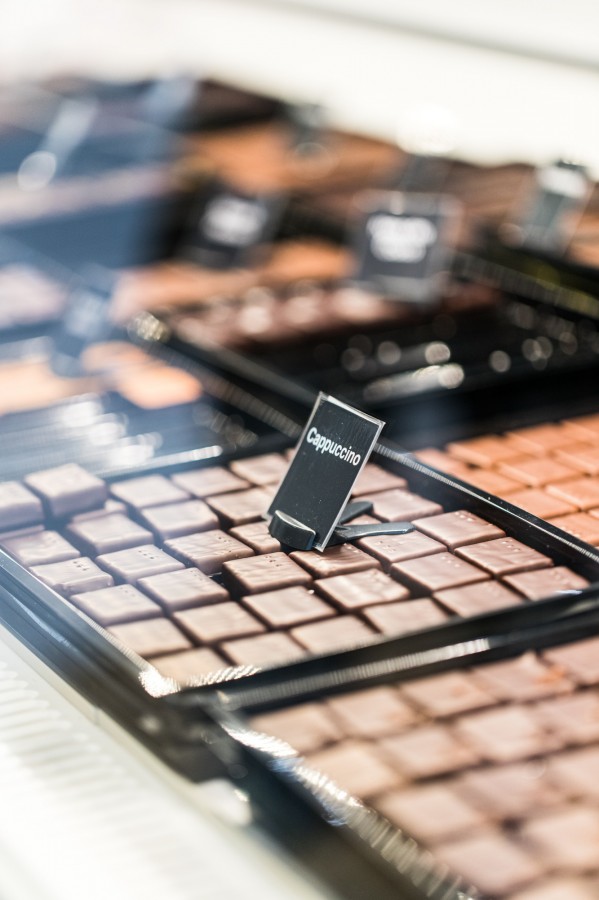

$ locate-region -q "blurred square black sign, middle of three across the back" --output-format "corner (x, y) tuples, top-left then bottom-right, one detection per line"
(355, 192), (459, 303)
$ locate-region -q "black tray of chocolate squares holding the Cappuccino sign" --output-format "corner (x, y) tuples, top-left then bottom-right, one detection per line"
(0, 448), (599, 778)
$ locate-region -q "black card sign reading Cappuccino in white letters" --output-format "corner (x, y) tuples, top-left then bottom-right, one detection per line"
(268, 394), (384, 550)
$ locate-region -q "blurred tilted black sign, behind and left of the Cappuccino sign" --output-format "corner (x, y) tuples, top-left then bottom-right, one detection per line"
(184, 185), (283, 269)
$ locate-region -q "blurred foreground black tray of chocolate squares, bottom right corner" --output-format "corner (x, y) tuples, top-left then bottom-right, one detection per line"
(215, 600), (599, 900)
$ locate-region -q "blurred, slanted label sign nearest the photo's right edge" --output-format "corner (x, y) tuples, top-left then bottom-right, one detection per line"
(516, 161), (591, 252)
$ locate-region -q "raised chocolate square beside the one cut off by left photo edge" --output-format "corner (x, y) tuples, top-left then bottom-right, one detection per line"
(25, 463), (108, 517)
